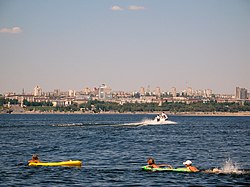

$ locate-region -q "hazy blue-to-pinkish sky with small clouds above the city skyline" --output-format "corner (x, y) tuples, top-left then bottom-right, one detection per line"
(0, 0), (250, 94)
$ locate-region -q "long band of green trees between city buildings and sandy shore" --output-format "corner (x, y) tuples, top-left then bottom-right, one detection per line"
(0, 97), (250, 113)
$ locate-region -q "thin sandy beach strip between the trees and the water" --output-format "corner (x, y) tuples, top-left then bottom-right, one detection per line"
(3, 111), (250, 116)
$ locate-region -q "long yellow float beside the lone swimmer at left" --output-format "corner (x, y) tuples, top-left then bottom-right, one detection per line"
(29, 160), (82, 167)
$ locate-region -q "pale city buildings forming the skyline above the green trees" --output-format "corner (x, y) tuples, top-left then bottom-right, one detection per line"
(4, 84), (250, 106)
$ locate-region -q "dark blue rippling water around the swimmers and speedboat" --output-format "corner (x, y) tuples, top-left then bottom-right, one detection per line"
(0, 115), (250, 186)
